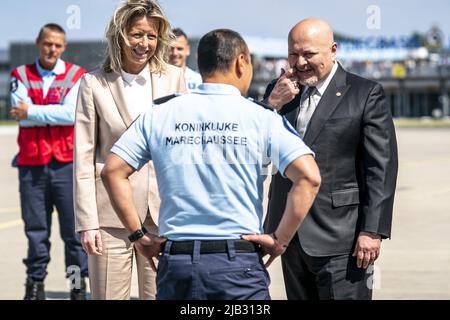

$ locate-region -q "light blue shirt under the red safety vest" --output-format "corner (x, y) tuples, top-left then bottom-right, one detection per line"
(11, 59), (81, 127)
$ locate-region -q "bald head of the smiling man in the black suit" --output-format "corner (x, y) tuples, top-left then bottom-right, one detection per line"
(288, 18), (336, 86)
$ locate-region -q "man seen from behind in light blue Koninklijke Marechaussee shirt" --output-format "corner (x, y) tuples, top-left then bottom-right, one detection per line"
(102, 29), (320, 299)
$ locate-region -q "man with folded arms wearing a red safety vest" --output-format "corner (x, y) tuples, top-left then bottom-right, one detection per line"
(10, 24), (88, 300)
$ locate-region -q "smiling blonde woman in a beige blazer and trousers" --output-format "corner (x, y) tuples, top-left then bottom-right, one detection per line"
(74, 0), (186, 299)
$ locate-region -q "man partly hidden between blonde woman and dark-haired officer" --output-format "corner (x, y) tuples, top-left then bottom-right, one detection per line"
(169, 28), (202, 91)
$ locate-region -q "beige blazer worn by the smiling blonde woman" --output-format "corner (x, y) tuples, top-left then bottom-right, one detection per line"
(74, 65), (186, 232)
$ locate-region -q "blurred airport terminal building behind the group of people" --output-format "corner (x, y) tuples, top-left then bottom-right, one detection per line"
(0, 29), (450, 120)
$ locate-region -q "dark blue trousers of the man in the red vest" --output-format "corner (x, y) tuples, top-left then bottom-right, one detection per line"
(19, 159), (88, 280)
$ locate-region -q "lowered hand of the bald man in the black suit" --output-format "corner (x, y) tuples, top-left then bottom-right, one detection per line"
(353, 232), (381, 269)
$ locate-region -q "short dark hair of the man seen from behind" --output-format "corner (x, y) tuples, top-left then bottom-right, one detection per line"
(197, 29), (249, 76)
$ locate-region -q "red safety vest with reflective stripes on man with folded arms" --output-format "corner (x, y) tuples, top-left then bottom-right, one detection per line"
(11, 62), (86, 166)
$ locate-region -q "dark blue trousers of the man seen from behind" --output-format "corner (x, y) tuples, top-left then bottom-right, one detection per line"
(156, 240), (270, 300)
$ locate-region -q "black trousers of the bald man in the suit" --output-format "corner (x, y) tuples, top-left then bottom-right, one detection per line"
(281, 235), (373, 300)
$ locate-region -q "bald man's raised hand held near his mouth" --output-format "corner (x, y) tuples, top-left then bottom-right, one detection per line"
(267, 68), (300, 110)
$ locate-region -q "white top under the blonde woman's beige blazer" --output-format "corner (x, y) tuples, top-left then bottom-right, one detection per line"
(122, 65), (153, 120)
